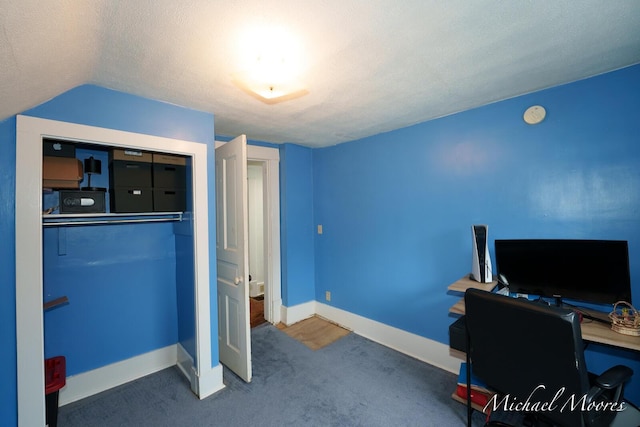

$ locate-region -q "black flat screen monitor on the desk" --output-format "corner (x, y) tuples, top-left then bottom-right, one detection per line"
(495, 239), (631, 304)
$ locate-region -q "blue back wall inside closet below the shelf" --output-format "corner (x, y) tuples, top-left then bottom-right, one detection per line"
(43, 223), (179, 375)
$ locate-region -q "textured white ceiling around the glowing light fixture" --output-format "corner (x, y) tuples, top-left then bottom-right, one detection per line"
(0, 0), (640, 147)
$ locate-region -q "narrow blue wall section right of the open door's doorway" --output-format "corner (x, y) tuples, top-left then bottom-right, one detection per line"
(280, 144), (315, 307)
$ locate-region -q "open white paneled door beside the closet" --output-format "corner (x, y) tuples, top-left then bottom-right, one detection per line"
(216, 135), (251, 382)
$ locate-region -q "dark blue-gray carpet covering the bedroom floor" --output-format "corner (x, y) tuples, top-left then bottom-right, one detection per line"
(58, 324), (496, 427)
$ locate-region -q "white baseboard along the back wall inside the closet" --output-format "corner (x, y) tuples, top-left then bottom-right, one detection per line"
(59, 344), (177, 406)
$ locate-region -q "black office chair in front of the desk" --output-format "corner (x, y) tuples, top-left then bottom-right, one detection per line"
(464, 289), (633, 427)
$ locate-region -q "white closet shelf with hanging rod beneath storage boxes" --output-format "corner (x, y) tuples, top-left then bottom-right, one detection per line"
(42, 212), (183, 227)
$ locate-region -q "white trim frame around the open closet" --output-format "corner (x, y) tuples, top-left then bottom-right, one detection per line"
(15, 115), (224, 427)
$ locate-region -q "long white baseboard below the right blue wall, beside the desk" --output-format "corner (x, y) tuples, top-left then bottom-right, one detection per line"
(315, 301), (461, 375)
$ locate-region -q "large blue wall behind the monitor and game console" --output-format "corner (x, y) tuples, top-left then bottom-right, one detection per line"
(313, 66), (640, 403)
